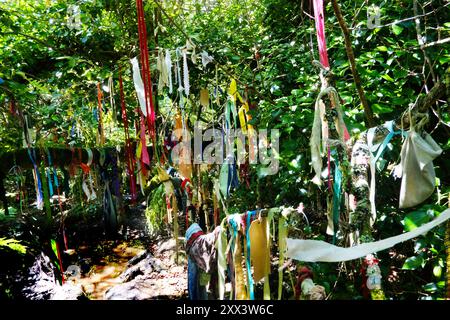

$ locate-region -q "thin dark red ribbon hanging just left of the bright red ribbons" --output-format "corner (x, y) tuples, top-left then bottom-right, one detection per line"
(119, 67), (137, 204)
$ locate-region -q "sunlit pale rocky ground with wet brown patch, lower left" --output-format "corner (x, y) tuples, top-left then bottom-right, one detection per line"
(71, 239), (187, 300)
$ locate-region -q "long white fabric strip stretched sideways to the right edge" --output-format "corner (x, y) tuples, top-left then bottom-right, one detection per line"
(286, 209), (450, 262)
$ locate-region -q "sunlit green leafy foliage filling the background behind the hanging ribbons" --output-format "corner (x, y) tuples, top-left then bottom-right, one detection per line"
(0, 0), (450, 298)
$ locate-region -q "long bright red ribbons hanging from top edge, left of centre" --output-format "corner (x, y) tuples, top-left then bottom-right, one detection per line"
(136, 0), (157, 148)
